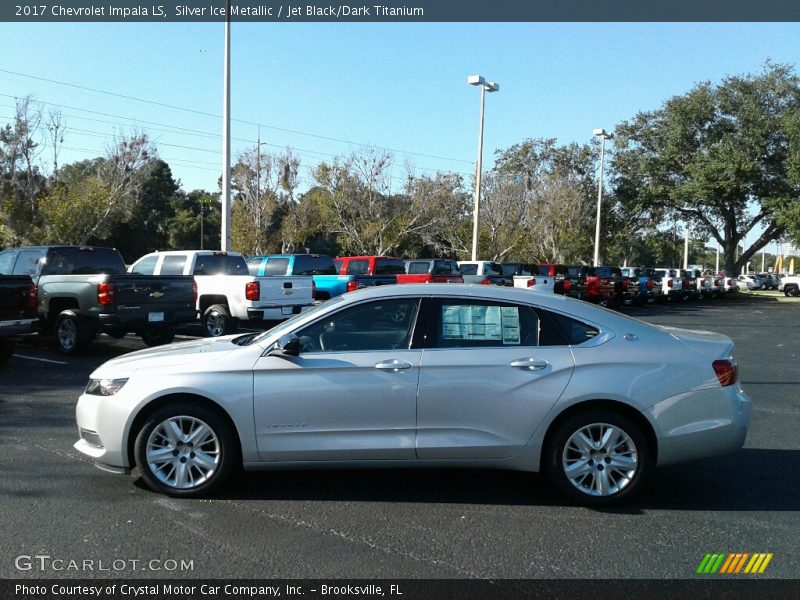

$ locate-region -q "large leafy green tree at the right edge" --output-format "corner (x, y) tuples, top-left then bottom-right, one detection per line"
(612, 63), (800, 273)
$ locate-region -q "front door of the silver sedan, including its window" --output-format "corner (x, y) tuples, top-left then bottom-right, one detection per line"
(253, 297), (422, 461)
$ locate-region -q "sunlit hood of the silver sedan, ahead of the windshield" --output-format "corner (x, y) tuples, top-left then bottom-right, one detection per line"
(92, 334), (242, 377)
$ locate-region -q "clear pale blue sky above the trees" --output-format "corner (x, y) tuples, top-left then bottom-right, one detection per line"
(0, 22), (800, 253)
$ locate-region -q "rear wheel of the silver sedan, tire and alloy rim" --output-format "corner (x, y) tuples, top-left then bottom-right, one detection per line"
(545, 410), (654, 506)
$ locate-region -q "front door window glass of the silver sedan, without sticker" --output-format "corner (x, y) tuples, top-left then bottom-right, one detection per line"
(297, 298), (419, 353)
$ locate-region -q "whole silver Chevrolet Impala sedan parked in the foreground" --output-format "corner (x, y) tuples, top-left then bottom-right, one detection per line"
(75, 284), (750, 505)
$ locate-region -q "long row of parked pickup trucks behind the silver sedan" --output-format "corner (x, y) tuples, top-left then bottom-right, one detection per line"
(0, 246), (800, 360)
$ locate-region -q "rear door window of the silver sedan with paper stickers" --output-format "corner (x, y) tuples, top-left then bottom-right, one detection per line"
(434, 298), (539, 348)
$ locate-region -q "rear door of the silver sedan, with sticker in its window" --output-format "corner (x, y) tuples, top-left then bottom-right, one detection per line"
(417, 297), (574, 459)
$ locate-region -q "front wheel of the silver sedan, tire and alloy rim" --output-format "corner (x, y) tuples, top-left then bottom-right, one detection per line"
(134, 403), (241, 498)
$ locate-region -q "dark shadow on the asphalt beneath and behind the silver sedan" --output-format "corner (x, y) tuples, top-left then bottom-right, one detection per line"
(203, 448), (800, 514)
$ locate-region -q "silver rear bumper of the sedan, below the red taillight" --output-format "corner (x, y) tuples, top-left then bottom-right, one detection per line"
(646, 384), (752, 465)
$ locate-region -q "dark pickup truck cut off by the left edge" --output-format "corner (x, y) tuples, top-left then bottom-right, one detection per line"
(0, 274), (39, 365)
